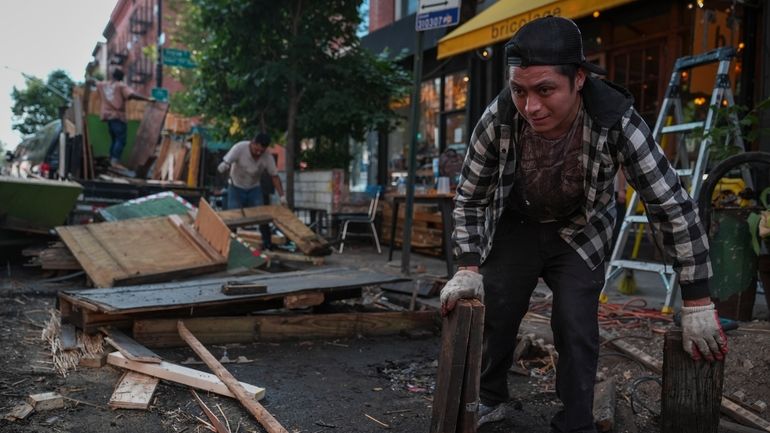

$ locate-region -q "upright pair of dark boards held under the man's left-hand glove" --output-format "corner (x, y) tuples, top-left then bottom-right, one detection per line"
(430, 299), (484, 433)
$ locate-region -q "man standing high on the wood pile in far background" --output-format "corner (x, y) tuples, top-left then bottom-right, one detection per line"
(96, 69), (152, 176)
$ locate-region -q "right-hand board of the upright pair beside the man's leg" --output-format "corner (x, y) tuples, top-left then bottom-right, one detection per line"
(456, 299), (485, 433)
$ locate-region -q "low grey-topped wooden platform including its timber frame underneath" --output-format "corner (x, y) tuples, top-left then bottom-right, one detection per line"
(59, 268), (402, 332)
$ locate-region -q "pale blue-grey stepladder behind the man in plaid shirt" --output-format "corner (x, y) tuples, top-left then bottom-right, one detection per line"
(599, 47), (743, 314)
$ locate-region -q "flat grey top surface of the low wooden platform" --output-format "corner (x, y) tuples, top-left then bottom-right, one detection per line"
(60, 267), (402, 314)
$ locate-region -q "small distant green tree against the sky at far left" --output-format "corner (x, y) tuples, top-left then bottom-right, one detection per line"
(11, 70), (75, 135)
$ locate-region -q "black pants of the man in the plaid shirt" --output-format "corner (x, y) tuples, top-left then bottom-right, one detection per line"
(480, 211), (604, 433)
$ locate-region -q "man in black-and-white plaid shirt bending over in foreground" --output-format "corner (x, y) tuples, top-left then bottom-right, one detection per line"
(441, 16), (727, 433)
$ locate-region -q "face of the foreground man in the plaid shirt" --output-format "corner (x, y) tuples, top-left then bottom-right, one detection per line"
(511, 66), (585, 139)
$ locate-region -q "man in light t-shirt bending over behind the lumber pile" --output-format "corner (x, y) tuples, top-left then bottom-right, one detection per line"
(218, 133), (286, 250)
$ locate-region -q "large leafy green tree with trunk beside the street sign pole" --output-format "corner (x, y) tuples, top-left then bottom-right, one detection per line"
(178, 0), (409, 203)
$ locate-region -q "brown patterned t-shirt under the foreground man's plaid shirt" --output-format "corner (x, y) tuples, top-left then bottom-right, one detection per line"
(509, 108), (585, 222)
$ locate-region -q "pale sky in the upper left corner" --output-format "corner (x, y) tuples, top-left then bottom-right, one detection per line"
(0, 0), (117, 149)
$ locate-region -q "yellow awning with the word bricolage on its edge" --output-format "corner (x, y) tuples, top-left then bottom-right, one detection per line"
(438, 0), (634, 59)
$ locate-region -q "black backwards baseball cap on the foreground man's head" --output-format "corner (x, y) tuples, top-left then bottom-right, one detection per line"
(505, 15), (607, 75)
